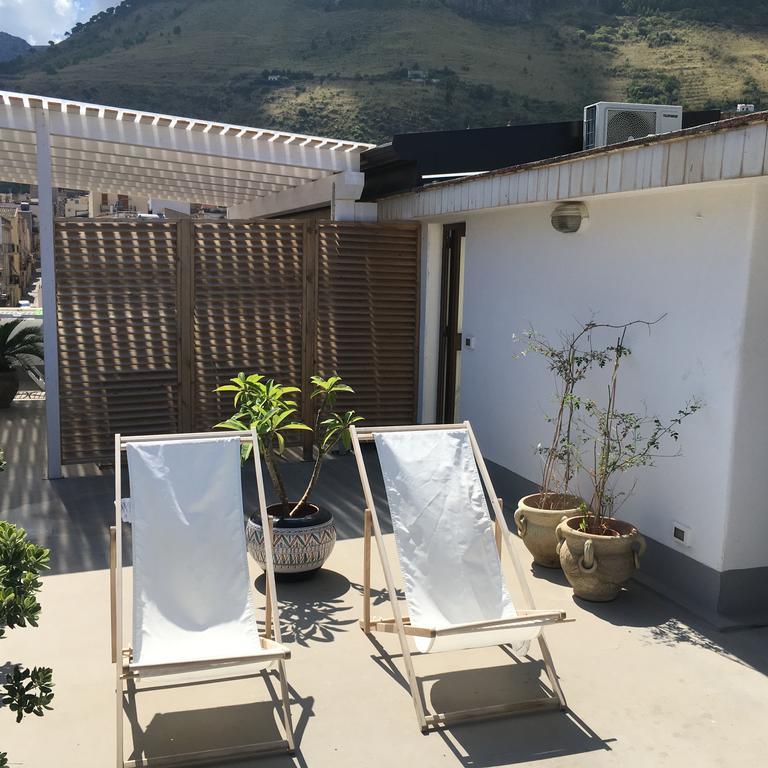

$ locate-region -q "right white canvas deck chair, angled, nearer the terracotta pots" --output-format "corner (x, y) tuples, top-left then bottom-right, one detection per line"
(350, 422), (566, 732)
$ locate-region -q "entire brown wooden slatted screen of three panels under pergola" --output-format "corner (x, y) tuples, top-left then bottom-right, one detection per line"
(56, 219), (419, 464)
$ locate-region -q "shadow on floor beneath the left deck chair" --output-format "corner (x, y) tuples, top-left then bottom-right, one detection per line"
(123, 671), (314, 768)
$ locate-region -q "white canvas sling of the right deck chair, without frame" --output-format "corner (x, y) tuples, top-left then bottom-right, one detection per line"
(374, 429), (541, 655)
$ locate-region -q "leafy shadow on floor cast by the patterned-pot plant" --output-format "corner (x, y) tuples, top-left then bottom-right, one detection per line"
(254, 568), (357, 647)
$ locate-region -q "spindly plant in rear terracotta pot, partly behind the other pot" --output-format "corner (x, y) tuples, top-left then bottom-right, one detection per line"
(515, 321), (608, 568)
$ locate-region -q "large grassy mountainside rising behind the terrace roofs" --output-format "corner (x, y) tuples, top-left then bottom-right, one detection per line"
(0, 0), (768, 141)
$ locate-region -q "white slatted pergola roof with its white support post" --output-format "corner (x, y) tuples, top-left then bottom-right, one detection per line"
(0, 91), (373, 477)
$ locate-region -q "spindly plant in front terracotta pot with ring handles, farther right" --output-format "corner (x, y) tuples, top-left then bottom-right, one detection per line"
(557, 321), (702, 602)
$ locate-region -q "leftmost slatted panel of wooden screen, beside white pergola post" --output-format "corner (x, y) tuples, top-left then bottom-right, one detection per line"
(56, 220), (178, 464)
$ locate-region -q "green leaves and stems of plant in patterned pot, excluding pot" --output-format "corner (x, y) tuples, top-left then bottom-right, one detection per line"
(215, 373), (362, 517)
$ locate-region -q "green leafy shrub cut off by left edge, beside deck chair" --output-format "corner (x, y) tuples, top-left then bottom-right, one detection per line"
(0, 449), (53, 768)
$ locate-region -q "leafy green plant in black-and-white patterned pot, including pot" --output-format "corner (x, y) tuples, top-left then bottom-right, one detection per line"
(216, 373), (362, 578)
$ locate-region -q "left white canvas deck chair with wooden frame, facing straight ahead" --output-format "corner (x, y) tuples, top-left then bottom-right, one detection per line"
(110, 432), (294, 768)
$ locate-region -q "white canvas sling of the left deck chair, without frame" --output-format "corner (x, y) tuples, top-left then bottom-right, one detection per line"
(126, 437), (264, 670)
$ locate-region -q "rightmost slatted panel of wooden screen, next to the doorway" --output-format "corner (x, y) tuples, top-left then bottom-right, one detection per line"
(316, 222), (420, 425)
